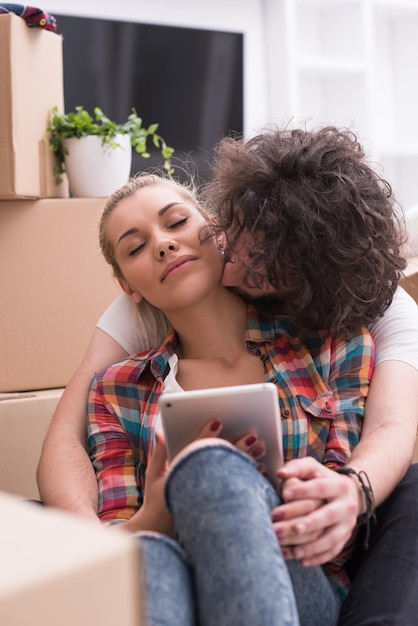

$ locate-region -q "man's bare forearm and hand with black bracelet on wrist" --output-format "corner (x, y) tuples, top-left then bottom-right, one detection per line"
(276, 361), (418, 565)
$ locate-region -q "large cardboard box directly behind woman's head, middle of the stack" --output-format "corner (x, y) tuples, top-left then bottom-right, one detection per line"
(0, 198), (121, 392)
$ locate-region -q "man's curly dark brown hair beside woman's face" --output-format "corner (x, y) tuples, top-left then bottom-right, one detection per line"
(204, 126), (406, 337)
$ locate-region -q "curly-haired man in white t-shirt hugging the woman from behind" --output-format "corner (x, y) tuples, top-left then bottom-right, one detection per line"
(39, 124), (418, 626)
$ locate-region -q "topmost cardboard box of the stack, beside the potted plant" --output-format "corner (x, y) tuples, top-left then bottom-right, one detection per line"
(0, 13), (68, 199)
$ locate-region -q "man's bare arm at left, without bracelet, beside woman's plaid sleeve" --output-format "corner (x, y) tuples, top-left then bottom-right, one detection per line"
(37, 328), (127, 519)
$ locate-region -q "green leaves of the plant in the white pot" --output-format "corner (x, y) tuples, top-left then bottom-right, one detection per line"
(47, 106), (174, 183)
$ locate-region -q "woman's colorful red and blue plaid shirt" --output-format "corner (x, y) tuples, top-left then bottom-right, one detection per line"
(88, 305), (374, 595)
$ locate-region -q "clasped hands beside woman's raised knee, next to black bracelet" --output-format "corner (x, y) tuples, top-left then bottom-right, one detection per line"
(272, 457), (362, 566)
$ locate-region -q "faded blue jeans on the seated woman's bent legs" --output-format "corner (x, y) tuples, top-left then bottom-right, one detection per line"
(139, 442), (340, 626)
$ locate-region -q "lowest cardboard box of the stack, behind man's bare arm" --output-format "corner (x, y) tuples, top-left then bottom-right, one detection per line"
(0, 389), (64, 500)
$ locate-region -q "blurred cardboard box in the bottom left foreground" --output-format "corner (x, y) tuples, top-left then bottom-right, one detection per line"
(0, 493), (144, 626)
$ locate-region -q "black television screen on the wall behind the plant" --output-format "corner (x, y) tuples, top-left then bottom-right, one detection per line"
(54, 14), (243, 180)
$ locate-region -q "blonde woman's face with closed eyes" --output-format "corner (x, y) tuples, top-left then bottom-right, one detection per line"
(106, 184), (223, 313)
